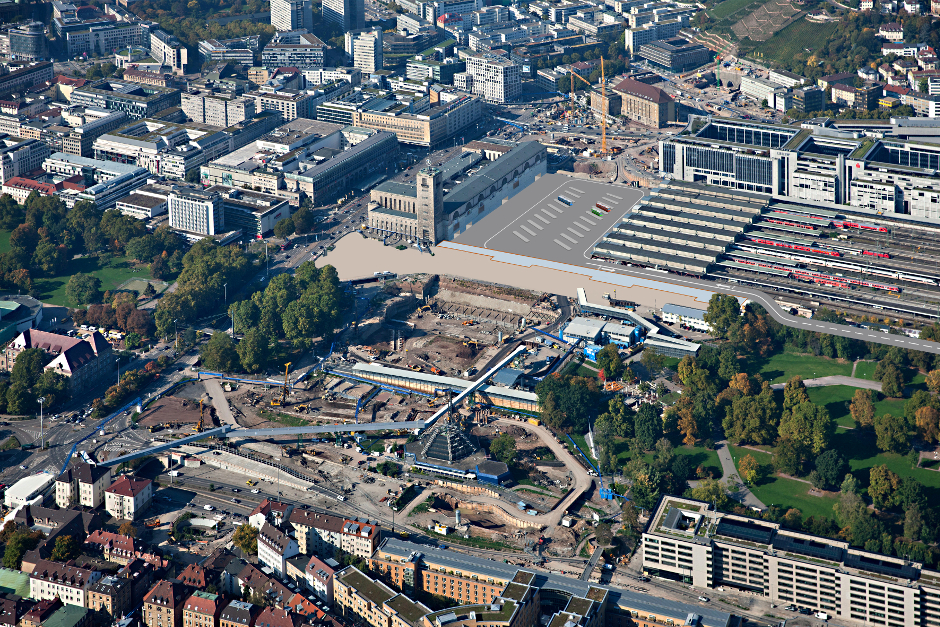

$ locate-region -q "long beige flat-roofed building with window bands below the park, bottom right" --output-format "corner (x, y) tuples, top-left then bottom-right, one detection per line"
(642, 496), (940, 627)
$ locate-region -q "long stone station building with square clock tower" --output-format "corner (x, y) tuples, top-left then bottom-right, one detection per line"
(369, 142), (548, 244)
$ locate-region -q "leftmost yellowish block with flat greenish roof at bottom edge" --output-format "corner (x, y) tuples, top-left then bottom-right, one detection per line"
(334, 566), (431, 627)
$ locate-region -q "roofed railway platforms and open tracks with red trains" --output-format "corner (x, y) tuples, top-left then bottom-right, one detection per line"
(592, 180), (940, 320)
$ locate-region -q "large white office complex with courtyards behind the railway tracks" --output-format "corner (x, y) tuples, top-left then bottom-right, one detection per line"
(659, 117), (940, 220)
